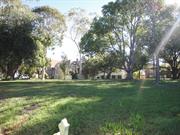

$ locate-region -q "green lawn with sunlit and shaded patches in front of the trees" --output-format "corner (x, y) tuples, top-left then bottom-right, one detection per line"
(0, 81), (180, 135)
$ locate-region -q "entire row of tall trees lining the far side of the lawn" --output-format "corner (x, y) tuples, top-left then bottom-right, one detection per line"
(0, 0), (180, 82)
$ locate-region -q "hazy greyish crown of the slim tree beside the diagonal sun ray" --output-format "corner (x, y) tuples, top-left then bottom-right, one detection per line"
(143, 0), (175, 56)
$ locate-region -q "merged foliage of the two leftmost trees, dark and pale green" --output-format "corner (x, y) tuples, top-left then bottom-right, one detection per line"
(0, 0), (65, 79)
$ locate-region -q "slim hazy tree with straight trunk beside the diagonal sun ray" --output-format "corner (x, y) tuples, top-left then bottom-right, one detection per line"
(144, 0), (174, 83)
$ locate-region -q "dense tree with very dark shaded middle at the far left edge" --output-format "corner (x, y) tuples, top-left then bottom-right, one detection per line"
(0, 3), (36, 79)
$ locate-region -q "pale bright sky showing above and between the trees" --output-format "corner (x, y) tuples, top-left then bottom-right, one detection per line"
(22, 0), (176, 61)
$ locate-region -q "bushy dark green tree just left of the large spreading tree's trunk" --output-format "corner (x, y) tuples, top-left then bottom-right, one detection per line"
(80, 17), (119, 79)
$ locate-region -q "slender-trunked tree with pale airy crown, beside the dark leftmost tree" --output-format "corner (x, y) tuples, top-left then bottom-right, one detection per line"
(33, 6), (66, 79)
